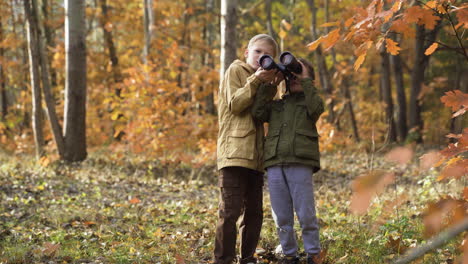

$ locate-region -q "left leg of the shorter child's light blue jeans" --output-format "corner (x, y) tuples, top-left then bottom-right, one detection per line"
(267, 166), (297, 256)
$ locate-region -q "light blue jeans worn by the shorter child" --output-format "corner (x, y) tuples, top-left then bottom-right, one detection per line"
(267, 164), (320, 256)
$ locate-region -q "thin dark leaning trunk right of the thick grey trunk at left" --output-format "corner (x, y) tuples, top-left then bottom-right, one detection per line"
(98, 0), (123, 98)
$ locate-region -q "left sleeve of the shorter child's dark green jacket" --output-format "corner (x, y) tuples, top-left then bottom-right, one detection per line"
(252, 84), (276, 122)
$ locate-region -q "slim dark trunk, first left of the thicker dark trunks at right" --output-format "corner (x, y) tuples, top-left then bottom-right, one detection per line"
(380, 45), (397, 142)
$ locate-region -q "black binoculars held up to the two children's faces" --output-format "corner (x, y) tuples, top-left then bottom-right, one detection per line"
(258, 51), (302, 80)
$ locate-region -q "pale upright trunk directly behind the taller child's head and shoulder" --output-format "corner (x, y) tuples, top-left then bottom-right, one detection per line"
(219, 0), (238, 81)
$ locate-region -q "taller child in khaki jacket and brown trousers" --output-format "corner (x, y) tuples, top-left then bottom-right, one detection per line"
(214, 34), (279, 264)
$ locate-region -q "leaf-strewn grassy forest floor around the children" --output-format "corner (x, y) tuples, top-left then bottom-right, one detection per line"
(0, 152), (464, 264)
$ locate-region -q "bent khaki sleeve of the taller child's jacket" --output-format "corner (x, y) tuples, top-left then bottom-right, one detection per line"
(225, 66), (261, 115)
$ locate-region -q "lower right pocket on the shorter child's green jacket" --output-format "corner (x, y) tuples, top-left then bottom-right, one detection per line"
(294, 129), (320, 160)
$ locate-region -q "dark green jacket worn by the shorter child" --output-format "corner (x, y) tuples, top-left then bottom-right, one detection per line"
(252, 79), (324, 172)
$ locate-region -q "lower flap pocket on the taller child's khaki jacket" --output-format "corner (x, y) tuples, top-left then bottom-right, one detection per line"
(226, 129), (256, 160)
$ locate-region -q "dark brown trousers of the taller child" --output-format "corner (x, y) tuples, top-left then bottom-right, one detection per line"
(214, 167), (263, 264)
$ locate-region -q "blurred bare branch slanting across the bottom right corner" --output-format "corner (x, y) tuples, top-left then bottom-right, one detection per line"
(394, 217), (468, 264)
